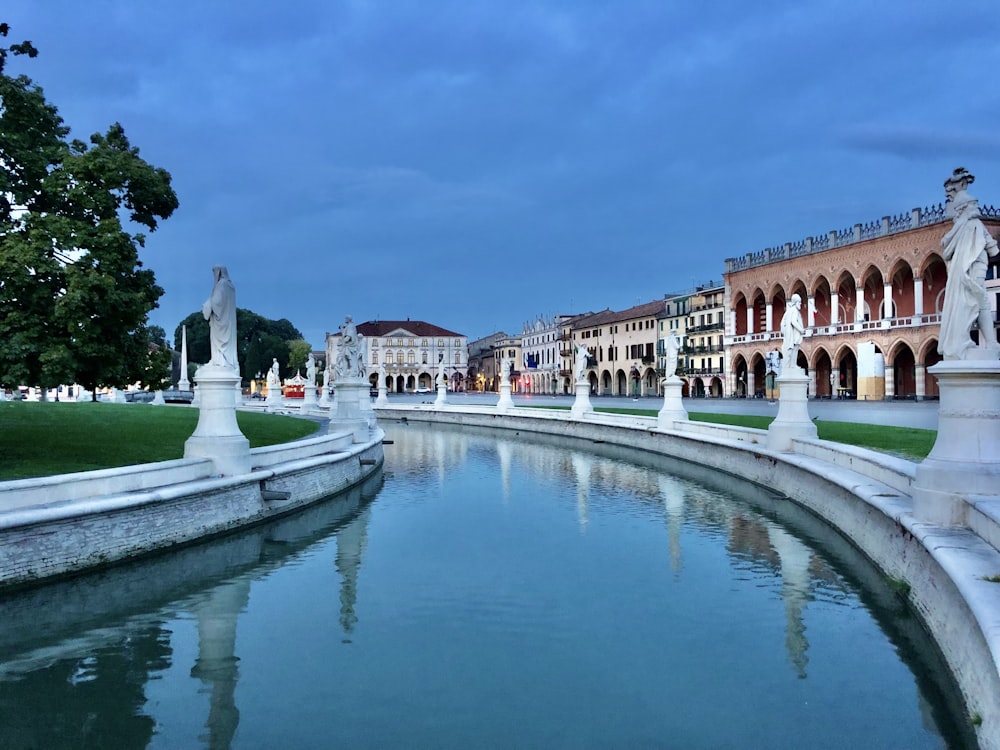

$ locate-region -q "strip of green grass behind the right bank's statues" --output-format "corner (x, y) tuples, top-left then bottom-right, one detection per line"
(543, 406), (937, 461)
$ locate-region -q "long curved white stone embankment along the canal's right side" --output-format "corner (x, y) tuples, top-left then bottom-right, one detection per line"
(376, 405), (1000, 750)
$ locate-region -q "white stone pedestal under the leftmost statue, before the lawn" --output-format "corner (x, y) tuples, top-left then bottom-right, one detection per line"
(184, 365), (250, 476)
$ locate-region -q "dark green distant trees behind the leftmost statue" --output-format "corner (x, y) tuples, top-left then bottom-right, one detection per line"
(174, 307), (308, 380)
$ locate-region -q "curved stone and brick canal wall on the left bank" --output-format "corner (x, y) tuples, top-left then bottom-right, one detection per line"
(0, 429), (383, 591)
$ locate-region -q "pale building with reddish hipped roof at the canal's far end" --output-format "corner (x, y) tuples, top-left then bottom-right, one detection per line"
(326, 320), (468, 393)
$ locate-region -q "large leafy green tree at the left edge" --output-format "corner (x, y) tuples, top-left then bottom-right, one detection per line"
(0, 24), (178, 391)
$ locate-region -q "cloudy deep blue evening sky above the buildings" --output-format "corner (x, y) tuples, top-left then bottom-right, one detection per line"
(0, 0), (1000, 349)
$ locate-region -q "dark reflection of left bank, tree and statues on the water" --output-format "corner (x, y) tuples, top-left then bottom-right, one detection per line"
(0, 476), (382, 750)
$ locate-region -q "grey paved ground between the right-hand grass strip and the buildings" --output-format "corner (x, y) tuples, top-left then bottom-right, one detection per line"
(389, 393), (938, 430)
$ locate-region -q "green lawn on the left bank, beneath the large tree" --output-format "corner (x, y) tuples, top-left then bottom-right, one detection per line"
(0, 401), (317, 480)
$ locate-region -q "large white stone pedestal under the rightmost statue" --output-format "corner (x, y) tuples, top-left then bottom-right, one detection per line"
(913, 360), (1000, 526)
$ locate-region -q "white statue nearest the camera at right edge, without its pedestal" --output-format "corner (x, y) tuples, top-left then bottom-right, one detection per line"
(938, 167), (998, 359)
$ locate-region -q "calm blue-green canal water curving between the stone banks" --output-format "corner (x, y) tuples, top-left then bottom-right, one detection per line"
(0, 425), (975, 749)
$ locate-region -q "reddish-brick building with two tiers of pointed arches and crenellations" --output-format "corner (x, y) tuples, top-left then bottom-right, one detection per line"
(725, 200), (1000, 400)
